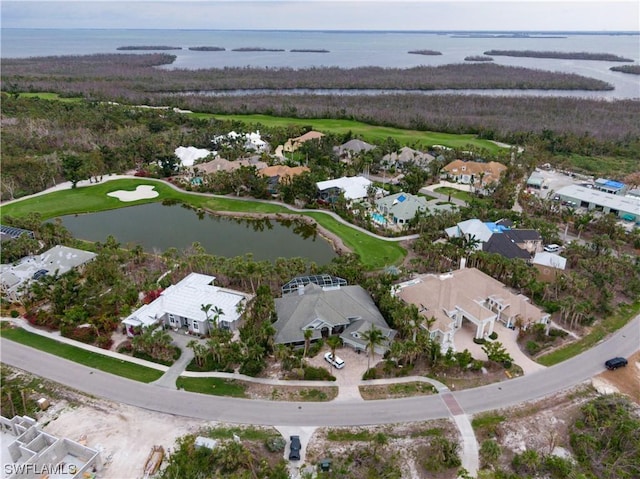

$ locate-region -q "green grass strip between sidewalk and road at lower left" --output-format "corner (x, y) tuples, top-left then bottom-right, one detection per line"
(2, 325), (163, 383)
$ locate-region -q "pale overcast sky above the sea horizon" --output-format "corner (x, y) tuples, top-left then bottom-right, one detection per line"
(0, 0), (640, 31)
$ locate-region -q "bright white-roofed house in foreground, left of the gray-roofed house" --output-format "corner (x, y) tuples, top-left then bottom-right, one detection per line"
(122, 273), (249, 336)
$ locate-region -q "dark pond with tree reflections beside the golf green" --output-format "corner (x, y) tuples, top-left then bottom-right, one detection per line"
(60, 203), (336, 265)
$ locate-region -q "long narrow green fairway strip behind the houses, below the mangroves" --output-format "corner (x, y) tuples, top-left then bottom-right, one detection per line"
(193, 113), (504, 153)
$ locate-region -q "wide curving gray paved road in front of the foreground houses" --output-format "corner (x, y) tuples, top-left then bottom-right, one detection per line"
(0, 315), (640, 426)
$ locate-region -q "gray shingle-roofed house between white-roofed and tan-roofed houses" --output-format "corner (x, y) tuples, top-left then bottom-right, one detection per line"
(273, 283), (396, 354)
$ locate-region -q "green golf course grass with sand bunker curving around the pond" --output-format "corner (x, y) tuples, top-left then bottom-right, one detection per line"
(0, 178), (406, 269)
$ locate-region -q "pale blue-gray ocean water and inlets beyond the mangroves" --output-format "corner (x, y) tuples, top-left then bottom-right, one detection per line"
(0, 29), (640, 99)
